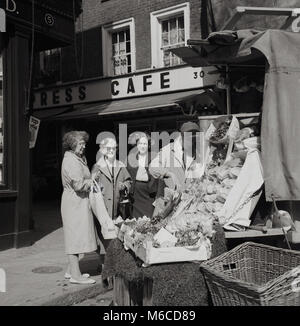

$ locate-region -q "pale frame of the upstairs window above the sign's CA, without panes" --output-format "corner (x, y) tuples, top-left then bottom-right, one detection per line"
(101, 18), (136, 76)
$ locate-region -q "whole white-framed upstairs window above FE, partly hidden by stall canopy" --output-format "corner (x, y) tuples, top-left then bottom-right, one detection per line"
(150, 3), (190, 68)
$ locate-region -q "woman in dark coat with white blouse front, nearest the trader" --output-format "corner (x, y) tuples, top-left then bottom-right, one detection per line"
(127, 133), (158, 218)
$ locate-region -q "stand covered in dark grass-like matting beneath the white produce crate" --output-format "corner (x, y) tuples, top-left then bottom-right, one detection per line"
(102, 226), (227, 306)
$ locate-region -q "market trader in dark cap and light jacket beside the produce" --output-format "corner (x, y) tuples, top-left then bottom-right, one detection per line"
(149, 122), (204, 190)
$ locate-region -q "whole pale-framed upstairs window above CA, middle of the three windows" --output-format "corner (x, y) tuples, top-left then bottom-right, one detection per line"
(102, 18), (135, 76)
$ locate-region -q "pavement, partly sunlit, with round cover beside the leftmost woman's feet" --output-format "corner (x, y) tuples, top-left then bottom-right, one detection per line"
(0, 202), (112, 306)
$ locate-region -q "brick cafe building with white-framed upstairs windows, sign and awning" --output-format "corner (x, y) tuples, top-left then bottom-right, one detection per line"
(33, 0), (221, 204)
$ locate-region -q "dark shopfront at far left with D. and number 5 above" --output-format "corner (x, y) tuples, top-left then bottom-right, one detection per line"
(0, 0), (79, 250)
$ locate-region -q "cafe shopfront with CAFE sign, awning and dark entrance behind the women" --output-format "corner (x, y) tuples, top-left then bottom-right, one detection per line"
(32, 66), (224, 201)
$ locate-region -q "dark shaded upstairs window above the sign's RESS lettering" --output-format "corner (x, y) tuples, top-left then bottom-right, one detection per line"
(39, 48), (62, 83)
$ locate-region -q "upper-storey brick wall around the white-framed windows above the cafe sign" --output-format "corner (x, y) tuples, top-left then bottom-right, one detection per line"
(58, 0), (201, 81)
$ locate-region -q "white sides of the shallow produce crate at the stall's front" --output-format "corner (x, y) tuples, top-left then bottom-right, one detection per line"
(124, 234), (209, 265)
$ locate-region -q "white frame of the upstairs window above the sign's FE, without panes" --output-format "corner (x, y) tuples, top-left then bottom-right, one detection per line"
(150, 2), (190, 68)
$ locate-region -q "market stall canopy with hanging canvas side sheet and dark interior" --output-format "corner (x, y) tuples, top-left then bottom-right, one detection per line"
(173, 30), (300, 241)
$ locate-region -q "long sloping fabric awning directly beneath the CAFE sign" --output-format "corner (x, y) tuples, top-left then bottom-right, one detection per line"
(45, 89), (212, 120)
